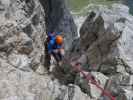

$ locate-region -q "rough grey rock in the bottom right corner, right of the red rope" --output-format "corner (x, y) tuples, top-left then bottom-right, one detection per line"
(103, 74), (132, 100)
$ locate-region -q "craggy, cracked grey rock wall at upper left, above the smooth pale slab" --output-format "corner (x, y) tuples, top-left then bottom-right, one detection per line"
(0, 0), (46, 70)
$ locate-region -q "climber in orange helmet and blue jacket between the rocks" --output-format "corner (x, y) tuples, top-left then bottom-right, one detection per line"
(48, 32), (64, 66)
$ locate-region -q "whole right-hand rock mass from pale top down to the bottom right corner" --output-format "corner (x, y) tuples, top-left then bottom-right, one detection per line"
(80, 4), (133, 100)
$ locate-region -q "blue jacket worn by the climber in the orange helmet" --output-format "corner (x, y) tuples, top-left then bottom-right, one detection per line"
(48, 32), (62, 53)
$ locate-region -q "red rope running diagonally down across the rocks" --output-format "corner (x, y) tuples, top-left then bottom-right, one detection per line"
(72, 64), (116, 100)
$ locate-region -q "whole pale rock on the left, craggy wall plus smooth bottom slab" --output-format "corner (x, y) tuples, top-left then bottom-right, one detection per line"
(0, 0), (90, 100)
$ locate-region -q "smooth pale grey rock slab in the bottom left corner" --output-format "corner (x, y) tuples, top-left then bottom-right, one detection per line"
(0, 59), (59, 100)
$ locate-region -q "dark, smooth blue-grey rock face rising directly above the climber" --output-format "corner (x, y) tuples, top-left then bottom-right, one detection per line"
(40, 0), (77, 50)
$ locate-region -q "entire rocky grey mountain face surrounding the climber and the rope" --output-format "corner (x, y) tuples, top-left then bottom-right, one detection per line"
(0, 0), (133, 100)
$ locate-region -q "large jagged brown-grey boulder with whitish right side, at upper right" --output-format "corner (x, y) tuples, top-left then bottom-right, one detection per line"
(80, 4), (133, 72)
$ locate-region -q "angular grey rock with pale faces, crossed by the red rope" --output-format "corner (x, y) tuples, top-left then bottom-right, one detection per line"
(75, 72), (108, 99)
